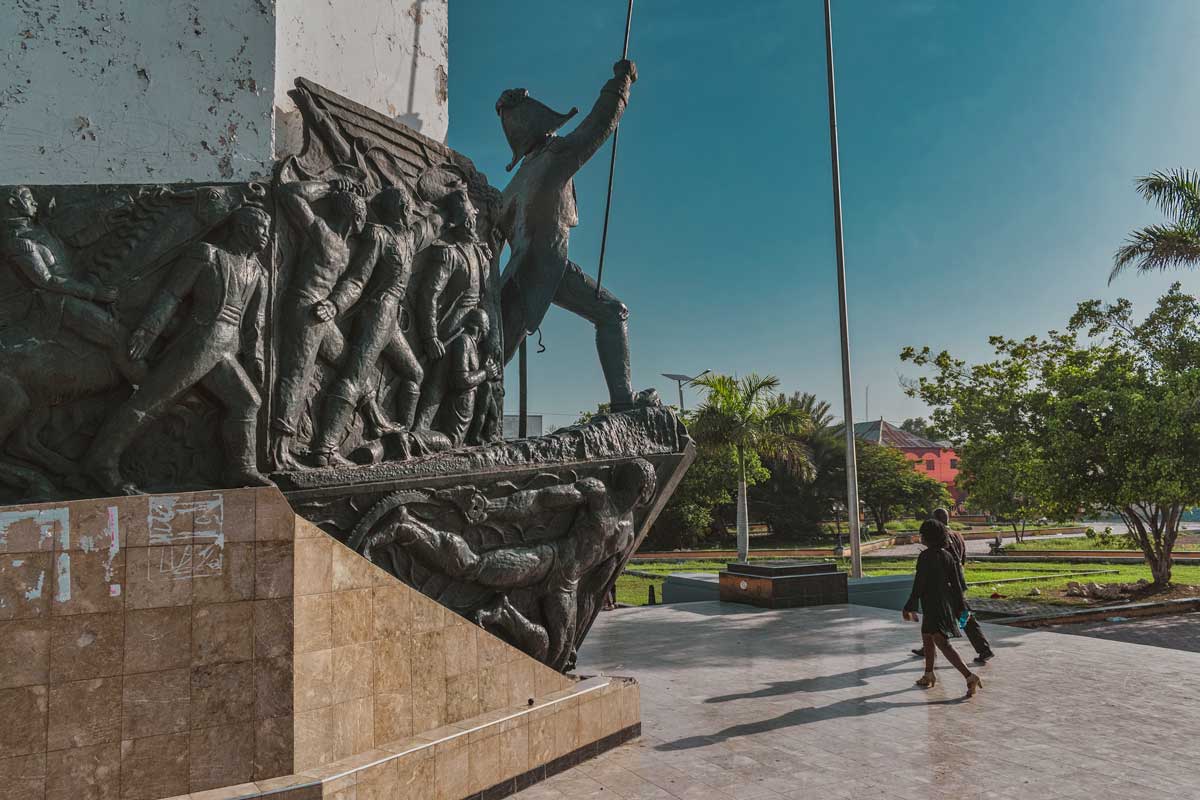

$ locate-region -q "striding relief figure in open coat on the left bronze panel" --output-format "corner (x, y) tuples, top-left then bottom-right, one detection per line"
(84, 206), (271, 494)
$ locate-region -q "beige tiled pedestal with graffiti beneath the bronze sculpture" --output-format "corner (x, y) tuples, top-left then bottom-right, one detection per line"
(0, 489), (640, 800)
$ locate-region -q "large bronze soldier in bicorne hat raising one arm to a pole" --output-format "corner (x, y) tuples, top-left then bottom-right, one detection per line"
(496, 60), (637, 411)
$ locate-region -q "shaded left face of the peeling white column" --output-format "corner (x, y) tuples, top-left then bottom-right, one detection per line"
(0, 0), (275, 184)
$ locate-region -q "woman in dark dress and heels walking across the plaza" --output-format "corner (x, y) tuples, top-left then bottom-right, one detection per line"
(904, 519), (983, 697)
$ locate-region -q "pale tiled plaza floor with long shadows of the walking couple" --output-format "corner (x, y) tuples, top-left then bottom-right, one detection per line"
(517, 602), (1200, 800)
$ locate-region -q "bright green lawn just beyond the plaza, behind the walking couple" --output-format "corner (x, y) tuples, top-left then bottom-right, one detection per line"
(617, 558), (1200, 606)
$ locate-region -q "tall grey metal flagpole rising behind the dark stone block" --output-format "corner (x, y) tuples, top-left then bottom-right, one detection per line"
(824, 0), (863, 578)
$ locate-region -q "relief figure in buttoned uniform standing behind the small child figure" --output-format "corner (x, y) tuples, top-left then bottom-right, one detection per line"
(416, 193), (499, 428)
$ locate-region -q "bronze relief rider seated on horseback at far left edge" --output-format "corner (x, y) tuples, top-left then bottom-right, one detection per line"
(0, 186), (145, 384)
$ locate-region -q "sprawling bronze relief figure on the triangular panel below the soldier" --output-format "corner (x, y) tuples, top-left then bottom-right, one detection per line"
(376, 459), (656, 669)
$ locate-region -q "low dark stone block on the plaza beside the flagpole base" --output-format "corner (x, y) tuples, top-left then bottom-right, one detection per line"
(720, 561), (847, 608)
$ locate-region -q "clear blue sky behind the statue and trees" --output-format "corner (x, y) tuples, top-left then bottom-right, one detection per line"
(449, 0), (1200, 425)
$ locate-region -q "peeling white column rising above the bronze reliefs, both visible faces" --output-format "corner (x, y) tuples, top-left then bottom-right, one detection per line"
(0, 0), (448, 185)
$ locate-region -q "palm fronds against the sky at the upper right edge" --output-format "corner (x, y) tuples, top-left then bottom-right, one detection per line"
(1109, 169), (1200, 283)
